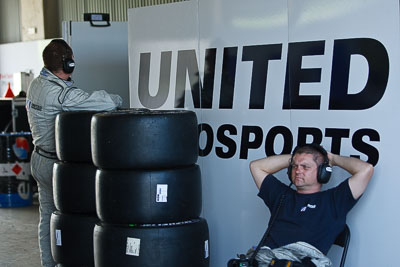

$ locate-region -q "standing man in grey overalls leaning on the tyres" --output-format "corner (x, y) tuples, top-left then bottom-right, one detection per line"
(26, 39), (122, 267)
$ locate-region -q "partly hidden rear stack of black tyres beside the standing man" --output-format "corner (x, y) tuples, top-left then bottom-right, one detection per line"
(50, 111), (99, 266)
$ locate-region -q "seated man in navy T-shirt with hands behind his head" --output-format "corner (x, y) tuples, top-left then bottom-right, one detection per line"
(250, 144), (373, 266)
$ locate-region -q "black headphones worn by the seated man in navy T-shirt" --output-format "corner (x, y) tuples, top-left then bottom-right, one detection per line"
(288, 143), (332, 184)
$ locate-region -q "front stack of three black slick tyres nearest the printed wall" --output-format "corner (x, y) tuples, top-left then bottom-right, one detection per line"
(91, 110), (209, 267)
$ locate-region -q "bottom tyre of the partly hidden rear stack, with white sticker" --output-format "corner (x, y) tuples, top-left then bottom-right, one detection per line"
(50, 211), (99, 267)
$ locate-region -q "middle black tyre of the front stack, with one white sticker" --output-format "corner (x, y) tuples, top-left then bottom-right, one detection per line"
(96, 165), (202, 223)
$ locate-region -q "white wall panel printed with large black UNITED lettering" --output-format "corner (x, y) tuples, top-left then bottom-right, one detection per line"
(128, 0), (400, 267)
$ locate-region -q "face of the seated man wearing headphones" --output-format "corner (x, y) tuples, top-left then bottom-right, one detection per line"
(291, 153), (321, 193)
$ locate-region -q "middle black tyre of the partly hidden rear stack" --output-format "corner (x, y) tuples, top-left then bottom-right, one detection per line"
(53, 162), (97, 215)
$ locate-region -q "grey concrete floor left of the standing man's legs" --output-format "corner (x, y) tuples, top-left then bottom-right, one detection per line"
(0, 204), (40, 267)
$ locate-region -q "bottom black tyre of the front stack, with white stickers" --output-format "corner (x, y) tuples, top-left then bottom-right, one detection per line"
(93, 219), (210, 267)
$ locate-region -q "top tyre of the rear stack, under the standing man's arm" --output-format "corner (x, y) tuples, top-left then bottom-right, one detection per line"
(55, 111), (98, 163)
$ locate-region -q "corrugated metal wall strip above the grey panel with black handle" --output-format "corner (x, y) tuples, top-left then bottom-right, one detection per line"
(59, 0), (187, 21)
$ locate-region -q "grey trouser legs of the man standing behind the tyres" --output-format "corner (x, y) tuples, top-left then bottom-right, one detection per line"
(31, 152), (57, 267)
